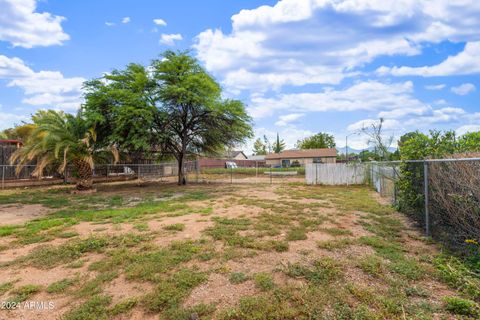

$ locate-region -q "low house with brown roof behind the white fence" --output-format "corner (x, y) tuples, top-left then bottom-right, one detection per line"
(265, 148), (337, 167)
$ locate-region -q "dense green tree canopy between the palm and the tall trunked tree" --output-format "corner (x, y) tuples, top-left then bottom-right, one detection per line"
(83, 63), (159, 161)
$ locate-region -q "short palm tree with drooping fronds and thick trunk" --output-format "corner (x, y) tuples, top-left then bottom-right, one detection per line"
(10, 110), (118, 190)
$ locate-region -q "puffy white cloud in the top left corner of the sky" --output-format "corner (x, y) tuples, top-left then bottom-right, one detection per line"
(0, 0), (70, 48)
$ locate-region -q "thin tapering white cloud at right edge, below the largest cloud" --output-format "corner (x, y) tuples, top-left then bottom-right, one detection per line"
(377, 41), (480, 77)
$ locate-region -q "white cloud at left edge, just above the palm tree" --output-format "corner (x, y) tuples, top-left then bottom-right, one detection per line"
(0, 55), (85, 110)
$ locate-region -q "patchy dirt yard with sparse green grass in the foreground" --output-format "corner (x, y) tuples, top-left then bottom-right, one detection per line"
(0, 181), (476, 319)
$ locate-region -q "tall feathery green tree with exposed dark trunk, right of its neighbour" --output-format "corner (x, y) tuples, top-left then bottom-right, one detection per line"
(153, 51), (252, 184)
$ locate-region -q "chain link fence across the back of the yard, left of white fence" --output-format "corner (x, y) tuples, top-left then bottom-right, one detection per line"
(0, 161), (305, 188)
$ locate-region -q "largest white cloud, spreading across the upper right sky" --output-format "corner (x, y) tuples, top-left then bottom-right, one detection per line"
(194, 0), (480, 92)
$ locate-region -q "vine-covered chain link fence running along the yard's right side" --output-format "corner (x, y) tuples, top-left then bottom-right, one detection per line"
(368, 158), (480, 253)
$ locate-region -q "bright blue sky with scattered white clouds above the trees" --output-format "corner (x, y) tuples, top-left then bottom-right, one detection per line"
(0, 0), (480, 154)
